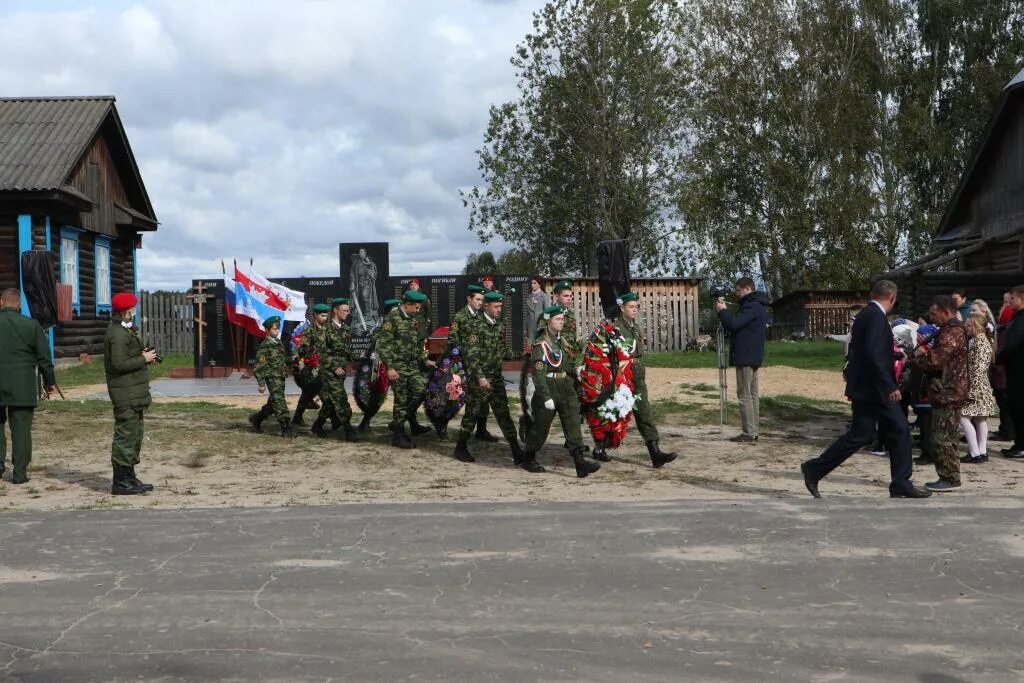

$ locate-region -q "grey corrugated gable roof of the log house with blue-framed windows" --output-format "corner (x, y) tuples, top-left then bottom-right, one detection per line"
(0, 96), (156, 221)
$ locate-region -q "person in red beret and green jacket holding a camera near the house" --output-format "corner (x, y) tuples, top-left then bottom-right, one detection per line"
(103, 292), (157, 496)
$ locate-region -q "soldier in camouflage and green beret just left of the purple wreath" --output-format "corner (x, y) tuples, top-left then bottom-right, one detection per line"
(377, 290), (434, 449)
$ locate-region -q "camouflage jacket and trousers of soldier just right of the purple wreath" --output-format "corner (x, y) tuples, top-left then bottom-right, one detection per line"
(461, 312), (519, 447)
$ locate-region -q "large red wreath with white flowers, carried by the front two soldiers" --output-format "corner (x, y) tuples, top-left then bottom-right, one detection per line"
(580, 321), (639, 447)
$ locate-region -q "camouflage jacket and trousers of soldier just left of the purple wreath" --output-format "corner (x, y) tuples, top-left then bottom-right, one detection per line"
(375, 306), (427, 432)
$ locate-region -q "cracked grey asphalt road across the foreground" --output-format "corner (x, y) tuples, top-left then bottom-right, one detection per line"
(0, 498), (1024, 683)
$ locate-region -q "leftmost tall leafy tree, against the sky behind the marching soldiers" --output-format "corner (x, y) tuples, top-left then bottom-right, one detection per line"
(462, 0), (690, 275)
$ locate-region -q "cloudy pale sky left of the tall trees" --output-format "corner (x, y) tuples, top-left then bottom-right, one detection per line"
(0, 0), (543, 290)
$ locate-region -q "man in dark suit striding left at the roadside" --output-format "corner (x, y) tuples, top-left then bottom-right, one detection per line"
(800, 280), (931, 498)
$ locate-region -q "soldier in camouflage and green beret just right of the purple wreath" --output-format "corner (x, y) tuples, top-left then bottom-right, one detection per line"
(455, 291), (523, 465)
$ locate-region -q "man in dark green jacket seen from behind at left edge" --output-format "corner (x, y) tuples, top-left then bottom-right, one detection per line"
(0, 289), (56, 483)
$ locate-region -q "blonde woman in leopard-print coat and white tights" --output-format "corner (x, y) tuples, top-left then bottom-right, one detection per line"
(959, 313), (995, 463)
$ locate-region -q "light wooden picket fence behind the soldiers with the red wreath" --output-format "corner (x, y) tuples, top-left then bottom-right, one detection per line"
(572, 278), (699, 352)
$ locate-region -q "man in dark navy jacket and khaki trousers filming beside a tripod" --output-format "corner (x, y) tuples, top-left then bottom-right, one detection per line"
(715, 278), (769, 443)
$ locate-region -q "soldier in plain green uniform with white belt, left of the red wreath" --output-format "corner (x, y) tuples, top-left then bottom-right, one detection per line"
(522, 305), (601, 478)
